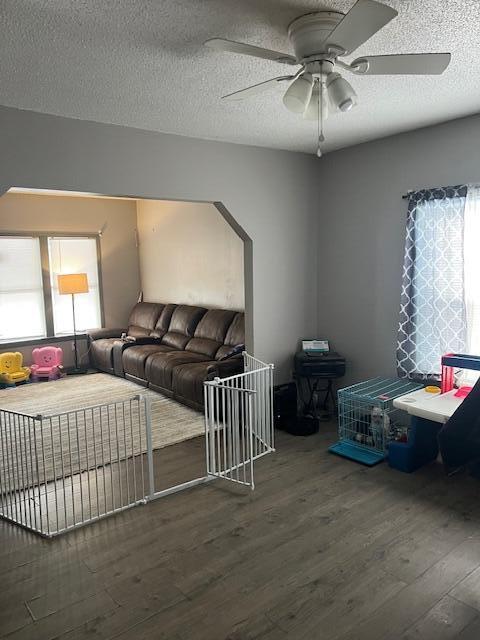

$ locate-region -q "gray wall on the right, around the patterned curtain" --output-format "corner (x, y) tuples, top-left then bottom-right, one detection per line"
(317, 116), (480, 383)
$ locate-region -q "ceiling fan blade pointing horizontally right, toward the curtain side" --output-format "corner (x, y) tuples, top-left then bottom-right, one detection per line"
(350, 53), (452, 76)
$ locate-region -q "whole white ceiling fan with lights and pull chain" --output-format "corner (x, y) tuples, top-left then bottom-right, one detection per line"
(205, 0), (451, 157)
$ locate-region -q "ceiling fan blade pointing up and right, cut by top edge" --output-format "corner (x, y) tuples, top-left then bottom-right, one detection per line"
(324, 0), (398, 55)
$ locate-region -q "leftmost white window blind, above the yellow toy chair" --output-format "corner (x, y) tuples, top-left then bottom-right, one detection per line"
(0, 237), (46, 342)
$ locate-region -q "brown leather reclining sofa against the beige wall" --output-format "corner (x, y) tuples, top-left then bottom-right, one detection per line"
(88, 302), (245, 410)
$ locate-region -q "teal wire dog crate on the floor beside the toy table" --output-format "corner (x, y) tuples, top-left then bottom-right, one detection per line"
(329, 378), (422, 466)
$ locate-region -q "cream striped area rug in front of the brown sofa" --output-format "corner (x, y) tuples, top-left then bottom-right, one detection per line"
(0, 373), (205, 493)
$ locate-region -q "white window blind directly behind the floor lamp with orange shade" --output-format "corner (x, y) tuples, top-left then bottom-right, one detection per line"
(48, 237), (102, 336)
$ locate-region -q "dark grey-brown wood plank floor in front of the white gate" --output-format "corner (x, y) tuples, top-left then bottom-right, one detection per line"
(0, 425), (480, 640)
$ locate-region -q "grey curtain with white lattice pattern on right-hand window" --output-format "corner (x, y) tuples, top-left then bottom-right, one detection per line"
(397, 185), (467, 379)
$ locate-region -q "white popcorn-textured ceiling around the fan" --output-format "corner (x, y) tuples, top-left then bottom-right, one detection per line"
(0, 0), (480, 152)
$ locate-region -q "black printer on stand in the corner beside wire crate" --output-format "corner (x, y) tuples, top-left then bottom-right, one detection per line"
(294, 351), (345, 429)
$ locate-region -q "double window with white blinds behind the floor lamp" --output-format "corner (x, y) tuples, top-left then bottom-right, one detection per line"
(0, 235), (102, 342)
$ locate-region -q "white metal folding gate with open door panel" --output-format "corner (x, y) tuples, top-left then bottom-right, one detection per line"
(0, 353), (274, 537)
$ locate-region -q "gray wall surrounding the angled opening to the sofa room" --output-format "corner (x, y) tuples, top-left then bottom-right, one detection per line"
(0, 107), (319, 381)
